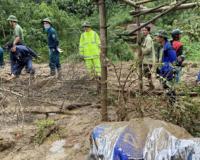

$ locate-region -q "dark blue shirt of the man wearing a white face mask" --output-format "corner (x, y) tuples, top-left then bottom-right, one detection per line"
(47, 27), (59, 49)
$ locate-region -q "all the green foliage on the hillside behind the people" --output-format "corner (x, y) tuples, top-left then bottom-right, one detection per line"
(0, 0), (200, 62)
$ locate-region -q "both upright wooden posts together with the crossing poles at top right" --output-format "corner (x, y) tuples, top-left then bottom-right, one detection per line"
(97, 0), (199, 121)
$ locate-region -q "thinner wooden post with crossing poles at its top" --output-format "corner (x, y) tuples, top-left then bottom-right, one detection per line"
(122, 0), (199, 93)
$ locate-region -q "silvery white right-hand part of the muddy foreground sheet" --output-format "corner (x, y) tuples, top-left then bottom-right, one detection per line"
(144, 128), (200, 160)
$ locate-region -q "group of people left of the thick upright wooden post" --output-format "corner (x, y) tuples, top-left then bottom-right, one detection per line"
(0, 15), (101, 79)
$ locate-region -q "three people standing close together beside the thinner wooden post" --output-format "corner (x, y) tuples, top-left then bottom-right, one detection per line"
(142, 26), (185, 89)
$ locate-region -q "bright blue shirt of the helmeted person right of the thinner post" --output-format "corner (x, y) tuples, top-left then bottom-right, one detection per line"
(162, 41), (176, 63)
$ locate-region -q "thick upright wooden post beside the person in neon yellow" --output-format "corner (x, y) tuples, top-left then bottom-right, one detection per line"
(98, 0), (108, 121)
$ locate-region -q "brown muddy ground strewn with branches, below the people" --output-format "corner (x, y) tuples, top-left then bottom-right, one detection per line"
(0, 62), (198, 160)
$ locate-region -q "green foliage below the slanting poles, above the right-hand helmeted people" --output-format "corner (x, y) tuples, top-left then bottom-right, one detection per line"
(156, 7), (200, 61)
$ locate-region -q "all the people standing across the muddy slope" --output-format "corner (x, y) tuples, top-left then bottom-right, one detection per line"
(0, 15), (199, 89)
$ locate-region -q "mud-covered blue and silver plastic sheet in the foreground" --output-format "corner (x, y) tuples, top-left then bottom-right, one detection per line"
(89, 118), (200, 160)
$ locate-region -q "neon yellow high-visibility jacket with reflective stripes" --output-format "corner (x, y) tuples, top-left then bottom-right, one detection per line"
(79, 30), (100, 59)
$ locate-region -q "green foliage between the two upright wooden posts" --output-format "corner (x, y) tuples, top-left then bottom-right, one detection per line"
(107, 2), (133, 61)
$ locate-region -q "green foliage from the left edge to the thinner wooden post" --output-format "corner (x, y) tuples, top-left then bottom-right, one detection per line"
(0, 0), (136, 62)
